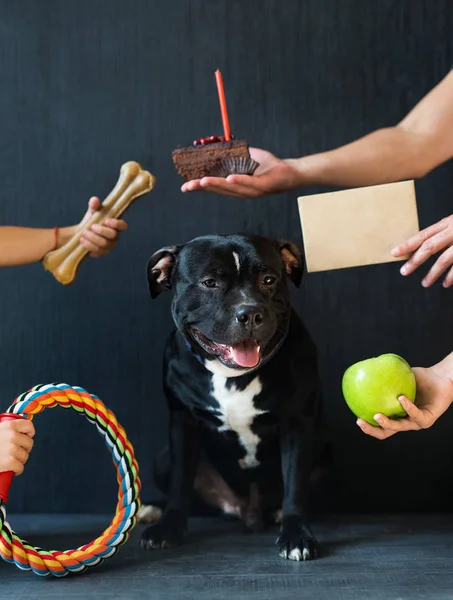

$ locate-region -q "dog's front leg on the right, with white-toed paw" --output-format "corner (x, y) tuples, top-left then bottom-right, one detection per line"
(277, 418), (317, 560)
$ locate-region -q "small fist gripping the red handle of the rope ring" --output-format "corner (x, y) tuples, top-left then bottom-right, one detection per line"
(0, 419), (35, 475)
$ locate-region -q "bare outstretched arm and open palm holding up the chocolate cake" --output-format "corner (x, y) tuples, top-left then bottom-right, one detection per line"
(182, 71), (453, 198)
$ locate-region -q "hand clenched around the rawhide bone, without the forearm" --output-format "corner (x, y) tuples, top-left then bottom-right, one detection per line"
(71, 196), (127, 258)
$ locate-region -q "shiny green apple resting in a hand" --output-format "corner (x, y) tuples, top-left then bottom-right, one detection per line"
(342, 354), (416, 427)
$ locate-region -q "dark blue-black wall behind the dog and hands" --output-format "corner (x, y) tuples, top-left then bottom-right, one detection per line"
(0, 0), (453, 512)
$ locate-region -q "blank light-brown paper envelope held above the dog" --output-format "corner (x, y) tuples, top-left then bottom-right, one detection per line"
(298, 181), (419, 273)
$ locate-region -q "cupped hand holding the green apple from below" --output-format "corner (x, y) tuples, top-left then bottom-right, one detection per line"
(357, 363), (453, 440)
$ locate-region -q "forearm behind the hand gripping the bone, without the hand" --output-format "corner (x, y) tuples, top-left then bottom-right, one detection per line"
(0, 227), (75, 267)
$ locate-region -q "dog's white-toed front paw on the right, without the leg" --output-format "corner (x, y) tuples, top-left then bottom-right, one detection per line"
(277, 515), (318, 561)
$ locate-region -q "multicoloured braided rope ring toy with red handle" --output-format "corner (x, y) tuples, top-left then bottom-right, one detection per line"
(0, 383), (141, 577)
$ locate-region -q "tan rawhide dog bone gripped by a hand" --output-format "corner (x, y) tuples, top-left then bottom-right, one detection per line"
(43, 161), (156, 285)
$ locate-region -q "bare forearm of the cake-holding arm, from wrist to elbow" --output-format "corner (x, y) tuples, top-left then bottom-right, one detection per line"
(285, 126), (436, 187)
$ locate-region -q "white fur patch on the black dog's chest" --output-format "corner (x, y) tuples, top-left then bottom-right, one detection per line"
(211, 374), (266, 469)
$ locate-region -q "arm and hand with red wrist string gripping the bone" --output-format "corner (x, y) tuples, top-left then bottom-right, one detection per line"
(0, 198), (127, 267)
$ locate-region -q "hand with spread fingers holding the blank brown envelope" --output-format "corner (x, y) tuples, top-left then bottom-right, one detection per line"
(392, 215), (453, 288)
